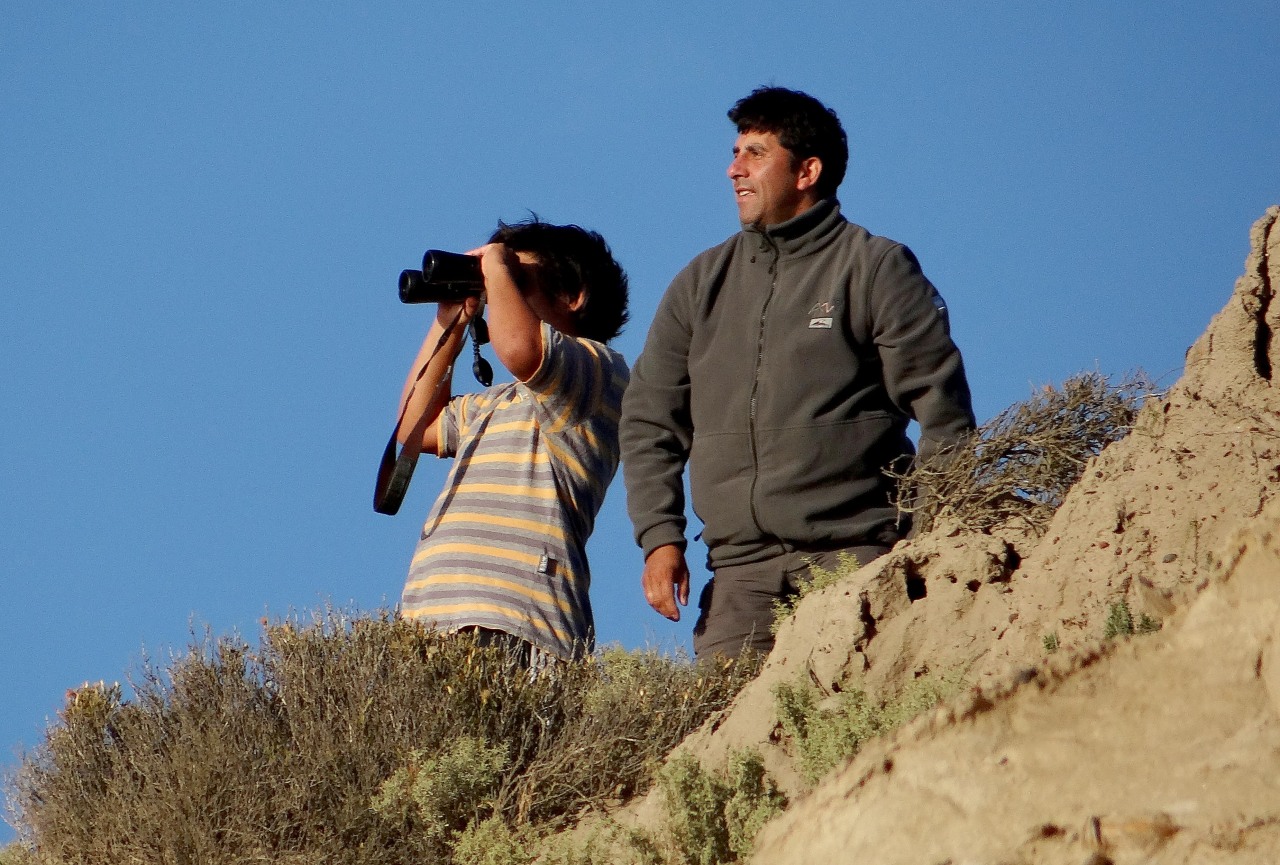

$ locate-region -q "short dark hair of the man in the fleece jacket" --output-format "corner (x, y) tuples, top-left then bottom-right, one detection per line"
(728, 87), (849, 198)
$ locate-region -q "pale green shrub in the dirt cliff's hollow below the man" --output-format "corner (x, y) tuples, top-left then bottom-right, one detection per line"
(773, 677), (959, 784)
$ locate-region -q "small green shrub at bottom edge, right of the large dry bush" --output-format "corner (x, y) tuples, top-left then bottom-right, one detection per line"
(658, 752), (786, 865)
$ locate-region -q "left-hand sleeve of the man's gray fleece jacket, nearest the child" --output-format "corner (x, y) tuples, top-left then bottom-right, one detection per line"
(620, 267), (694, 557)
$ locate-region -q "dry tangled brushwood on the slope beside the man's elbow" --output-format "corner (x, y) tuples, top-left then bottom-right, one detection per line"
(890, 372), (1155, 535)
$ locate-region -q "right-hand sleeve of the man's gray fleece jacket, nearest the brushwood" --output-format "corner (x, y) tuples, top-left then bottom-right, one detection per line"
(870, 243), (975, 457)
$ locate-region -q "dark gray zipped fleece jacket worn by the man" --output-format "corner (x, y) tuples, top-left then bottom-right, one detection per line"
(621, 198), (974, 568)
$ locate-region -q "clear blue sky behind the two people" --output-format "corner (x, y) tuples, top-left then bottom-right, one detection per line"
(0, 0), (1280, 839)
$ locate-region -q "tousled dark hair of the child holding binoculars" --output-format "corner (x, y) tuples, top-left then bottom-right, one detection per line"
(489, 215), (627, 343)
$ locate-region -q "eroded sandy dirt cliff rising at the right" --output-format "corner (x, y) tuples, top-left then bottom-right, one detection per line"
(747, 207), (1280, 865)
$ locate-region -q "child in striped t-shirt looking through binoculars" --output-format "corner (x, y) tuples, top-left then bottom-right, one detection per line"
(397, 219), (628, 668)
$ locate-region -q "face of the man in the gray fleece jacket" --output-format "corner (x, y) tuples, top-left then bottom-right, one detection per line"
(728, 132), (815, 225)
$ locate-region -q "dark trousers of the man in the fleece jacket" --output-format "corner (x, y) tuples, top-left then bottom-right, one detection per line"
(694, 544), (890, 658)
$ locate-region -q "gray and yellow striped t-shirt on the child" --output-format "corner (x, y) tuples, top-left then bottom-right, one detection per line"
(401, 322), (630, 658)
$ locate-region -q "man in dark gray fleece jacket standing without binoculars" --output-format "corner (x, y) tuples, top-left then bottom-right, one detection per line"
(621, 87), (974, 656)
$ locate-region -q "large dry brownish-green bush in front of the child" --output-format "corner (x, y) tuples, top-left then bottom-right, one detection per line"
(8, 610), (755, 865)
